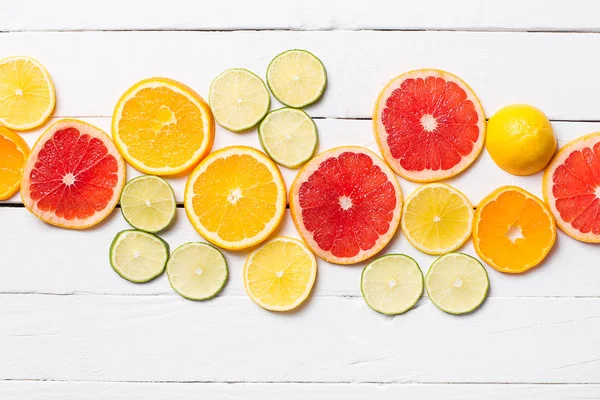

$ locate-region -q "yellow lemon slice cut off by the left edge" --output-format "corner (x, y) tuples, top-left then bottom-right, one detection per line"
(0, 56), (56, 131)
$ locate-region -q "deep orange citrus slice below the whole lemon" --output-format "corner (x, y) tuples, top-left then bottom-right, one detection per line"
(473, 186), (556, 274)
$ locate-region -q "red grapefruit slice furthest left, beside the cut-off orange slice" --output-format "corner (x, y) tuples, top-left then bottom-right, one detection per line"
(21, 119), (126, 229)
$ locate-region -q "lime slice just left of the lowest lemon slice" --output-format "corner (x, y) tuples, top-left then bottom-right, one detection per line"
(167, 242), (229, 300)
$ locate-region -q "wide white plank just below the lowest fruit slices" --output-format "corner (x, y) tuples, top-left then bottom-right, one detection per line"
(0, 295), (600, 383)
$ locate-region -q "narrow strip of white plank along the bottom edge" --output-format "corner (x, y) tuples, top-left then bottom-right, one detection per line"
(0, 381), (600, 400)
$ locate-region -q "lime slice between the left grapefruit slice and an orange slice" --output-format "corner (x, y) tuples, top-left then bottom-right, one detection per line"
(121, 175), (177, 233)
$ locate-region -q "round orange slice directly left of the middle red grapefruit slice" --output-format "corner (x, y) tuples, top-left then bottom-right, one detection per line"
(184, 146), (286, 250)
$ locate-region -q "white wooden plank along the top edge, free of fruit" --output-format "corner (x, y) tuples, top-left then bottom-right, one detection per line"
(0, 0), (598, 31)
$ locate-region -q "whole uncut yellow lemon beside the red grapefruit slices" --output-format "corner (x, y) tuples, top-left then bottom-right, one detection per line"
(485, 104), (556, 175)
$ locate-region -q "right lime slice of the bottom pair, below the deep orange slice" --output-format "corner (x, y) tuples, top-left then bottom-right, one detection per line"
(425, 253), (490, 314)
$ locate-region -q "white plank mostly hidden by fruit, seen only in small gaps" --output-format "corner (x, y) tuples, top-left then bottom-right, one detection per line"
(2, 117), (600, 205)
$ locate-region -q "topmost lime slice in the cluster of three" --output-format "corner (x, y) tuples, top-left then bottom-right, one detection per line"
(267, 50), (327, 108)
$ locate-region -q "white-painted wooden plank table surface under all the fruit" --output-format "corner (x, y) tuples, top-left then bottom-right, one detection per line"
(0, 0), (600, 400)
